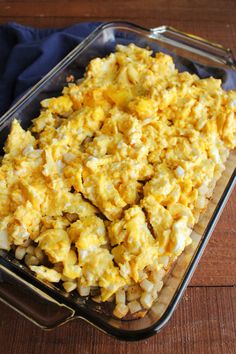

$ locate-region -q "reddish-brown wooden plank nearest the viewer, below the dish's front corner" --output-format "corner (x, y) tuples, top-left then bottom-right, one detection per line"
(0, 287), (236, 354)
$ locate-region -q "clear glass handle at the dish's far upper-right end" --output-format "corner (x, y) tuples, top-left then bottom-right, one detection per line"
(150, 26), (236, 69)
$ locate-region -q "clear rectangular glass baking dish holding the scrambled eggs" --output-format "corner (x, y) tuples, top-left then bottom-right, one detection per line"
(0, 22), (236, 340)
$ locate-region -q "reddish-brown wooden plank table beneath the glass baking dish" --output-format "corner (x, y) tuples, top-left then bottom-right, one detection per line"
(0, 0), (236, 354)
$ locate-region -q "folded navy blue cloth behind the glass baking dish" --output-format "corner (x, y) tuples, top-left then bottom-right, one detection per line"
(0, 22), (236, 116)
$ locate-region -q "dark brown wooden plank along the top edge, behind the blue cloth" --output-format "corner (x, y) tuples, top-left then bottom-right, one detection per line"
(0, 0), (235, 25)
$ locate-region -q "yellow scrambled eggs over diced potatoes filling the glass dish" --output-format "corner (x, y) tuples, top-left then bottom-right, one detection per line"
(0, 44), (236, 318)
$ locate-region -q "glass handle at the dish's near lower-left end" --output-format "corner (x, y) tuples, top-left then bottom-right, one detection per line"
(0, 264), (74, 329)
